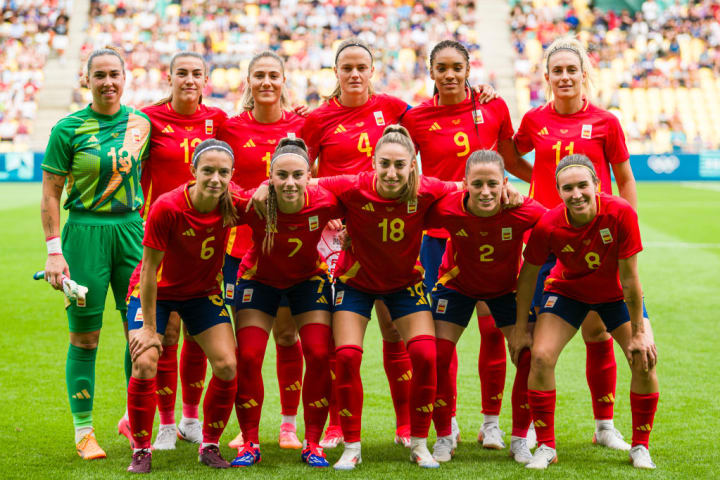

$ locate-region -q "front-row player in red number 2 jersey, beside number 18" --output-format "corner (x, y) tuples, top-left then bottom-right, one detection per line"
(426, 150), (545, 463)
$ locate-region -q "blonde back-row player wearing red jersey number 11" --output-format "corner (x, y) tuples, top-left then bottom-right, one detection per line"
(514, 37), (637, 450)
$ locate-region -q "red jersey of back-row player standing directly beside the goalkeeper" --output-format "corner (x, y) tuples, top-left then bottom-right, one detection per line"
(140, 102), (227, 219)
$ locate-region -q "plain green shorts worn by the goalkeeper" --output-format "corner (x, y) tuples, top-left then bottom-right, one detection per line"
(62, 211), (143, 333)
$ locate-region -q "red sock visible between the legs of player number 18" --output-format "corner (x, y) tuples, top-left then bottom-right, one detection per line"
(383, 340), (412, 427)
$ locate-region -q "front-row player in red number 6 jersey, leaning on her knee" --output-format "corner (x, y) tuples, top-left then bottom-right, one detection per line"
(128, 139), (246, 473)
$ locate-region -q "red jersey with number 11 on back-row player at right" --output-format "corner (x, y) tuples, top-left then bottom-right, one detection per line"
(515, 100), (630, 208)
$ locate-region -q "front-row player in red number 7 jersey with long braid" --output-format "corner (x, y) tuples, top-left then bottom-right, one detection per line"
(227, 138), (344, 467)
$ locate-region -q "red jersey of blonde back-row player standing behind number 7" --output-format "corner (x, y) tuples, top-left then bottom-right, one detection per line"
(217, 111), (305, 258)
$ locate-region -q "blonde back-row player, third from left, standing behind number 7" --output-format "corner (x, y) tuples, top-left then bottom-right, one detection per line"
(217, 51), (305, 448)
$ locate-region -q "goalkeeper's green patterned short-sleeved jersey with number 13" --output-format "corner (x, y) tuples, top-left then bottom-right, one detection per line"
(42, 105), (150, 213)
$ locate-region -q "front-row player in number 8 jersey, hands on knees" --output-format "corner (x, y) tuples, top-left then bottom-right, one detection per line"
(510, 155), (659, 469)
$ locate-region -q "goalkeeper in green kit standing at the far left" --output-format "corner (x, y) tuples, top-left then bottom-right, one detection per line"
(41, 48), (151, 459)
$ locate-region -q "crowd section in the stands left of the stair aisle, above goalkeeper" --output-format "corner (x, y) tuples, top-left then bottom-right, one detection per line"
(0, 0), (72, 150)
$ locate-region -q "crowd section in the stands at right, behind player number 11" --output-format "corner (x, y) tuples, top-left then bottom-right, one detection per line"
(510, 0), (720, 153)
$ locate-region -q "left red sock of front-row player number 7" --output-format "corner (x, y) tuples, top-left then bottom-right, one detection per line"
(235, 327), (269, 443)
